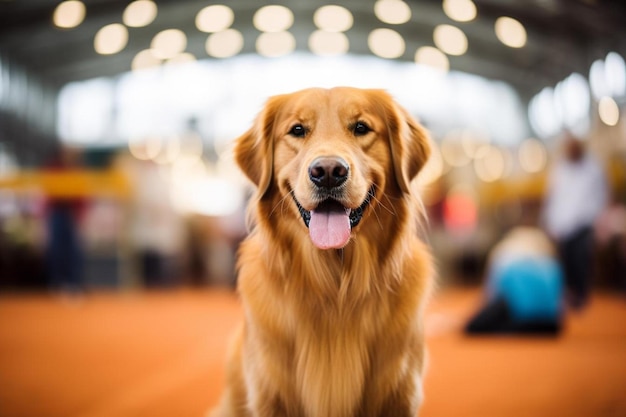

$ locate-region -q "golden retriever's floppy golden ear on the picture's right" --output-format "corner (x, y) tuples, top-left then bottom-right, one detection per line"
(388, 99), (430, 193)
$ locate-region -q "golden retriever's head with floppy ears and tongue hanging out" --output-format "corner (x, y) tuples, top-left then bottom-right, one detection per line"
(235, 87), (430, 249)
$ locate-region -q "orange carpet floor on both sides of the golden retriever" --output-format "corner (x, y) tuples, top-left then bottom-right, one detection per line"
(0, 289), (626, 417)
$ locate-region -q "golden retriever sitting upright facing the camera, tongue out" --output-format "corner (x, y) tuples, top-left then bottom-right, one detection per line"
(212, 87), (434, 417)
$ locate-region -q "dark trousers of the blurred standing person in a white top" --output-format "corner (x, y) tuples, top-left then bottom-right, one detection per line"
(558, 227), (593, 308)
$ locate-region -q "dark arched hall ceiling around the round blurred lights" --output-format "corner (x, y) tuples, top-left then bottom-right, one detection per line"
(0, 0), (626, 97)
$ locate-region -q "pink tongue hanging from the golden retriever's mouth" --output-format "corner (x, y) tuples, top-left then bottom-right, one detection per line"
(309, 203), (350, 249)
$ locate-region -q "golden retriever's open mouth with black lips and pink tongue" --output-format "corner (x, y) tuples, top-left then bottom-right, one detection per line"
(291, 186), (375, 249)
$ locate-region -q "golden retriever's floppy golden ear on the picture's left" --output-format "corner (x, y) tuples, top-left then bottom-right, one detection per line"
(234, 96), (281, 197)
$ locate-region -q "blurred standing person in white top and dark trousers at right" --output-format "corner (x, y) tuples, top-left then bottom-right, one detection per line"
(542, 133), (608, 309)
